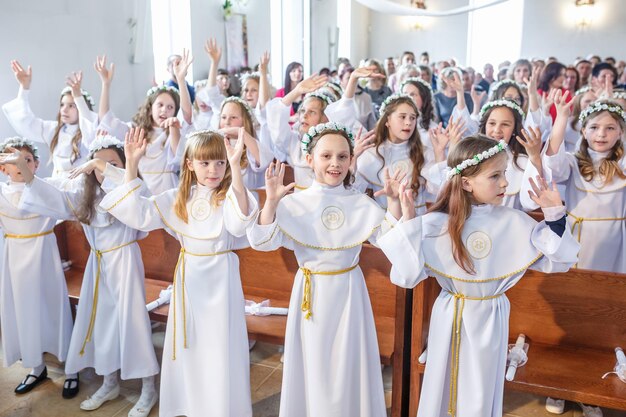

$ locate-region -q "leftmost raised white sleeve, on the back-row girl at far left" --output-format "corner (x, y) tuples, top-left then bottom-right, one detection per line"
(2, 87), (58, 145)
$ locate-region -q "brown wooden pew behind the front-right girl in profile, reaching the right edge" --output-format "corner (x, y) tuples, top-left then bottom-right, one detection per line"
(409, 269), (626, 415)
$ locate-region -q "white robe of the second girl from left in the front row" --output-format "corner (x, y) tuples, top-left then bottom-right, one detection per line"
(20, 170), (159, 379)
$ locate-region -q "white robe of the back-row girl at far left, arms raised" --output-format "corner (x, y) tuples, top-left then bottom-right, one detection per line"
(2, 87), (98, 177)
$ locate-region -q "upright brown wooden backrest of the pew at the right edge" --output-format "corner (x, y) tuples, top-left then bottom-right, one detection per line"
(506, 269), (626, 352)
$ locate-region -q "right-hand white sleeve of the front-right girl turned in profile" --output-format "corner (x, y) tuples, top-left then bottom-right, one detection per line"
(530, 206), (580, 272)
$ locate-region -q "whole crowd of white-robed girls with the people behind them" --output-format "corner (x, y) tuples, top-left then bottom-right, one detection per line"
(0, 39), (626, 417)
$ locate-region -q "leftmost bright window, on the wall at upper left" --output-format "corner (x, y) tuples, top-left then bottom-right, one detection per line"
(150, 0), (193, 84)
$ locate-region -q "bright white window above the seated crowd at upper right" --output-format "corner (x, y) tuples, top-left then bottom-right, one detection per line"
(467, 0), (524, 72)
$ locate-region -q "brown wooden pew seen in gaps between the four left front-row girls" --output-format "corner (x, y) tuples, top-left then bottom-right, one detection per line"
(57, 218), (411, 417)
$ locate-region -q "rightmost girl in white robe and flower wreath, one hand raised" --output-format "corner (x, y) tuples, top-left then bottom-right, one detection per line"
(528, 94), (626, 273)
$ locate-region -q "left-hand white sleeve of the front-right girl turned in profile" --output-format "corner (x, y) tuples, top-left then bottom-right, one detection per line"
(377, 216), (428, 288)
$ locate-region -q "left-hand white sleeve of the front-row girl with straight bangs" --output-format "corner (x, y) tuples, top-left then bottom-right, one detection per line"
(100, 178), (166, 232)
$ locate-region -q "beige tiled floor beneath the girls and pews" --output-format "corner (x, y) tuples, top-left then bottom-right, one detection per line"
(0, 326), (626, 417)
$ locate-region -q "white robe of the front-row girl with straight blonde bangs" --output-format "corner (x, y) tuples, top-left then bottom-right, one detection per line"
(100, 179), (257, 417)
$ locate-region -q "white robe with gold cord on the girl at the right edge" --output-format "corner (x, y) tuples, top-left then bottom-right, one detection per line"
(523, 144), (626, 273)
